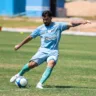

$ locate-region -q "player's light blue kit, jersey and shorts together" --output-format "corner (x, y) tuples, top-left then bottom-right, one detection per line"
(30, 22), (68, 65)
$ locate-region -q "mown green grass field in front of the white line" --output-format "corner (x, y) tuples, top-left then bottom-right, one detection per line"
(0, 32), (96, 96)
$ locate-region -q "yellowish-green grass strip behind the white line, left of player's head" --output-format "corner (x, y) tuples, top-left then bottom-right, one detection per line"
(0, 17), (42, 28)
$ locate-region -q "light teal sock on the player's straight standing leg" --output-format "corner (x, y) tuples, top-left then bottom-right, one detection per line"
(39, 67), (53, 84)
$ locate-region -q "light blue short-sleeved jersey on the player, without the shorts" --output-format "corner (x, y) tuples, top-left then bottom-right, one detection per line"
(31, 22), (67, 50)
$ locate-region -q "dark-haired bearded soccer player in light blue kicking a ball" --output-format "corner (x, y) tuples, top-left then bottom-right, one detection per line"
(10, 11), (89, 89)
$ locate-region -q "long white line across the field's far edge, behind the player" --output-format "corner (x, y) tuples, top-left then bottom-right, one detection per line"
(2, 27), (96, 36)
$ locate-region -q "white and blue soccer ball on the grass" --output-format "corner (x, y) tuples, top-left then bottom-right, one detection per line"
(15, 76), (28, 88)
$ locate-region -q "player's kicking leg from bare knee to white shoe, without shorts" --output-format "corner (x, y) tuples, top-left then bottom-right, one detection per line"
(10, 61), (38, 83)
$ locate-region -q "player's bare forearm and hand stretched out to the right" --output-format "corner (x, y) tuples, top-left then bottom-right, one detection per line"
(67, 20), (91, 29)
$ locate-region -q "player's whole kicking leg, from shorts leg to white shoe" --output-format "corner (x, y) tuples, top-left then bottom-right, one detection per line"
(10, 51), (47, 82)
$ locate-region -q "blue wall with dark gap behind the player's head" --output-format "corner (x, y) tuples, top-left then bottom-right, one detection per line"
(0, 0), (65, 17)
